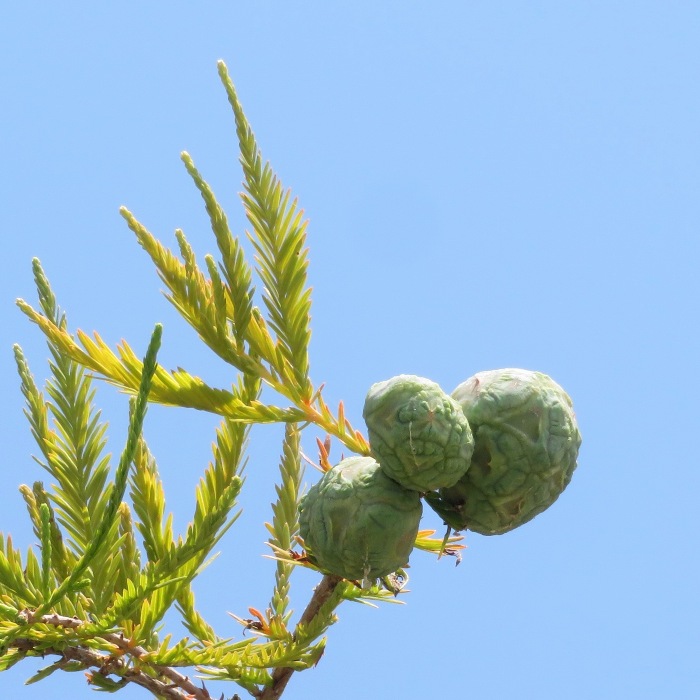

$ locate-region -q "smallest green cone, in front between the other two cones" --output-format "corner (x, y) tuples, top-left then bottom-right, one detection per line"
(362, 374), (474, 493)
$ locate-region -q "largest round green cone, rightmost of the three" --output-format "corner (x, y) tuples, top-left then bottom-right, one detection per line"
(426, 369), (581, 535)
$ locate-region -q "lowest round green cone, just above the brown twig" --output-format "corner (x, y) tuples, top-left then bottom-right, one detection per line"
(299, 457), (423, 580)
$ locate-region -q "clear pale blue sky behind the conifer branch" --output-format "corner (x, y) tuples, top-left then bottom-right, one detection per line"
(0, 0), (700, 700)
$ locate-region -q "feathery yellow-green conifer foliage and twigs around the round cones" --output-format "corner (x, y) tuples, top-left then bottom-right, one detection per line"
(0, 63), (461, 700)
